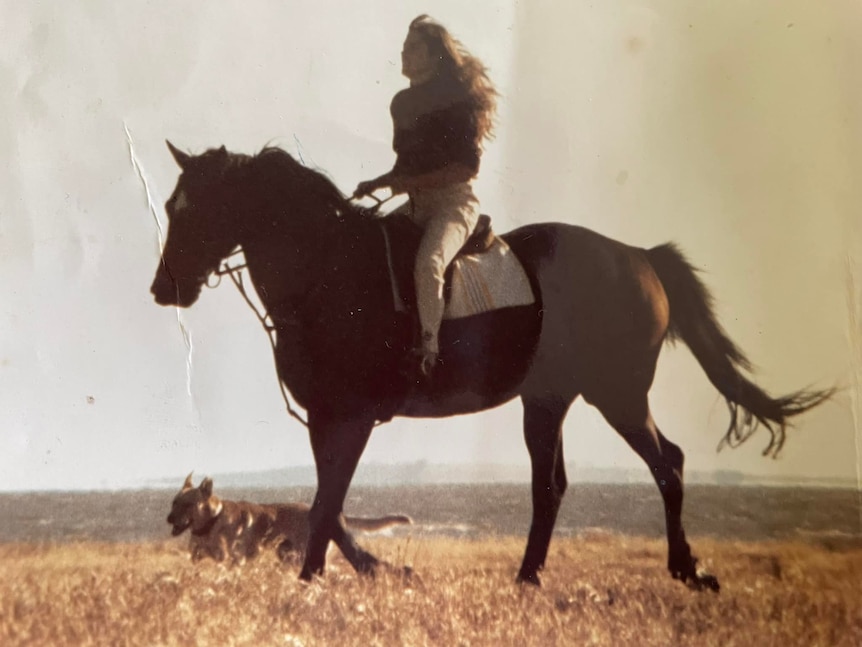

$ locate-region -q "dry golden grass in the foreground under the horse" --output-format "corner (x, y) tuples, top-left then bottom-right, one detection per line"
(0, 533), (862, 647)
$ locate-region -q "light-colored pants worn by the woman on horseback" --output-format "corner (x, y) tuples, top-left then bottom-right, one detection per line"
(410, 182), (479, 353)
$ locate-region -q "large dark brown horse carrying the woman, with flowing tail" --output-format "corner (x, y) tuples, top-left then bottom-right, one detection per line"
(152, 143), (831, 590)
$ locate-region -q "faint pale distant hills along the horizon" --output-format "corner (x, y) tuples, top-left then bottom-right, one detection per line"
(148, 461), (857, 489)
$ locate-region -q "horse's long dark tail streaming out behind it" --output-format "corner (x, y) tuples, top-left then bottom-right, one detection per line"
(647, 244), (834, 456)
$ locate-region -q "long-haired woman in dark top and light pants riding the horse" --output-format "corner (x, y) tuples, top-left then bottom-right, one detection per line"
(354, 15), (497, 377)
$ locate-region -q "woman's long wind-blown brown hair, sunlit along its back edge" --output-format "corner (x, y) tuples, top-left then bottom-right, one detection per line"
(410, 14), (497, 144)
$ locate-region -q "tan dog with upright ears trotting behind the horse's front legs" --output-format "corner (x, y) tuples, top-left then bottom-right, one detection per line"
(168, 474), (412, 564)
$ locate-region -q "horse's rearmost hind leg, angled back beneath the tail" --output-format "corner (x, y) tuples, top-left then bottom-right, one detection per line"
(593, 394), (719, 591)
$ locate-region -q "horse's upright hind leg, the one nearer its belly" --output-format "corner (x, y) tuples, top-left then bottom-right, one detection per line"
(518, 398), (570, 585)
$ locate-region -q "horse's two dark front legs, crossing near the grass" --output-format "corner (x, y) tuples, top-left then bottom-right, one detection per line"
(299, 411), (378, 580)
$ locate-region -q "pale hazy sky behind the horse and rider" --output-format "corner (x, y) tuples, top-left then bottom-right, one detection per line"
(0, 0), (862, 490)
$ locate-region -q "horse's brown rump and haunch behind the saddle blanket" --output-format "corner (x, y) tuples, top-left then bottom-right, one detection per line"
(504, 223), (668, 397)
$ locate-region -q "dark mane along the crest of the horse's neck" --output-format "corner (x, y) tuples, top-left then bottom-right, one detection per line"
(243, 146), (358, 218)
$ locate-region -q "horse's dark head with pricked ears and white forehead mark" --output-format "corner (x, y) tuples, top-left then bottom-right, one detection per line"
(150, 142), (243, 307)
